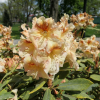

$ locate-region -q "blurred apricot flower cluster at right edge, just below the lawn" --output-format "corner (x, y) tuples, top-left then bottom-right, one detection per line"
(79, 35), (100, 60)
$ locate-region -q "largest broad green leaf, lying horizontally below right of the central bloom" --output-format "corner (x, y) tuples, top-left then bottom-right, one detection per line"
(58, 78), (93, 91)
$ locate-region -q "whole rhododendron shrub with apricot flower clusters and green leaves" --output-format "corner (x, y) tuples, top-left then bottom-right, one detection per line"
(0, 13), (100, 100)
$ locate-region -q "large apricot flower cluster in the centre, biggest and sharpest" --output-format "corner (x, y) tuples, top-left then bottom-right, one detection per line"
(18, 14), (78, 79)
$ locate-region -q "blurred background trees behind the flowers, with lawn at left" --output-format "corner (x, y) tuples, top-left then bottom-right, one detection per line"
(0, 0), (100, 38)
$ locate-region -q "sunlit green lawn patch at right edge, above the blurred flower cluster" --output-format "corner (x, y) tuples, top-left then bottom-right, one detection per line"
(85, 24), (100, 37)
